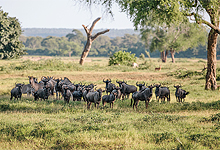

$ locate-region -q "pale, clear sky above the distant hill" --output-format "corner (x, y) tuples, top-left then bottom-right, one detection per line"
(0, 0), (134, 29)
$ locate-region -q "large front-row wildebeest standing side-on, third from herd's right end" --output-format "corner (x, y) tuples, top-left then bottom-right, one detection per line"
(132, 85), (154, 109)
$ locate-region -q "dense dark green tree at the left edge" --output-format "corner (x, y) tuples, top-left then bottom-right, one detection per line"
(0, 7), (26, 59)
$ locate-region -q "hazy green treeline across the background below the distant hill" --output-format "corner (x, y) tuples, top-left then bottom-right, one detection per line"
(20, 30), (220, 59)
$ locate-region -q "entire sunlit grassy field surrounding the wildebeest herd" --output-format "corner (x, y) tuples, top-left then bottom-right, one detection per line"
(0, 56), (220, 149)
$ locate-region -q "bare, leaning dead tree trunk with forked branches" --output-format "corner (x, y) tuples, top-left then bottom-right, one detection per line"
(79, 17), (109, 65)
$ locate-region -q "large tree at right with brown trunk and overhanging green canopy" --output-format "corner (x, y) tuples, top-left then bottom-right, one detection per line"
(80, 0), (220, 90)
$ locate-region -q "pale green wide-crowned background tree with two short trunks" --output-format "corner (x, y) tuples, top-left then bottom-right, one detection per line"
(141, 20), (207, 63)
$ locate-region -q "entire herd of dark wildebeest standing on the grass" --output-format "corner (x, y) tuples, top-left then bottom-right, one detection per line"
(10, 76), (189, 109)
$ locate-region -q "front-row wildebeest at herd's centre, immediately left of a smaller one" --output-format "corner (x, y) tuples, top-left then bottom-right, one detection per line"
(86, 89), (104, 109)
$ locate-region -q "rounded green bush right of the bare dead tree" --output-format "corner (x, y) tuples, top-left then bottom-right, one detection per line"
(109, 51), (137, 66)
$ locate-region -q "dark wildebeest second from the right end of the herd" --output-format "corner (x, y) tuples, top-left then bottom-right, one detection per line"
(154, 84), (170, 102)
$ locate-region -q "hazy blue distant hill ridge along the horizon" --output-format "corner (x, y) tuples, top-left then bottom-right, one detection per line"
(22, 28), (139, 38)
